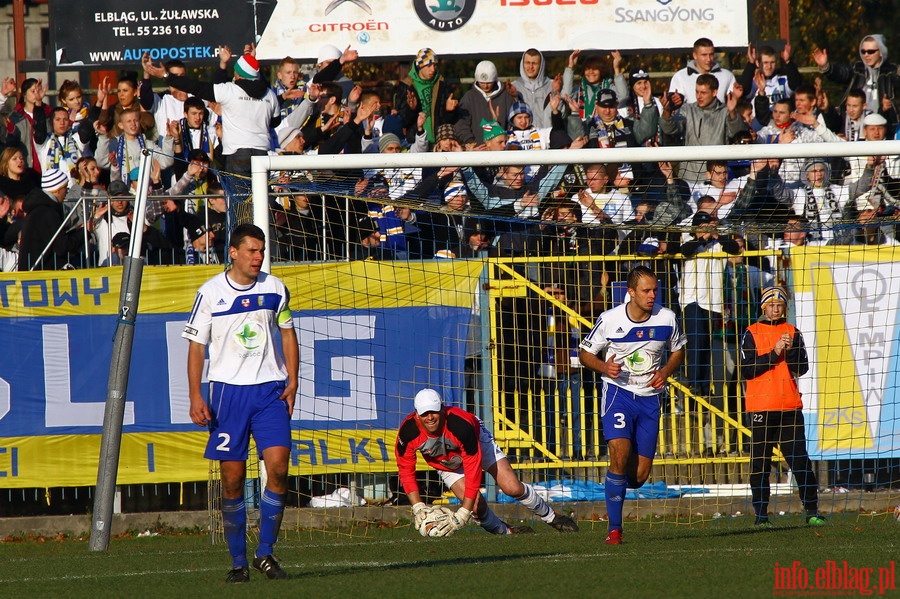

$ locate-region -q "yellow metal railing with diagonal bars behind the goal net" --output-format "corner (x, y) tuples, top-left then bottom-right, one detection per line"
(488, 251), (780, 469)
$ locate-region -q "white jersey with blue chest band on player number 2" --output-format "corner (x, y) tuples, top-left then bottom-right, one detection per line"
(181, 273), (293, 385)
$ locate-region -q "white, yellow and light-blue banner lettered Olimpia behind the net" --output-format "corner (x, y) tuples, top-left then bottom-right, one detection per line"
(791, 246), (900, 460)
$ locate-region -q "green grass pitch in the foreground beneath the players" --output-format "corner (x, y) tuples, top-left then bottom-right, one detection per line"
(0, 515), (900, 599)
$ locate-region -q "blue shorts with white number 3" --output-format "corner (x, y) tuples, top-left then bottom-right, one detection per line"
(600, 382), (659, 459)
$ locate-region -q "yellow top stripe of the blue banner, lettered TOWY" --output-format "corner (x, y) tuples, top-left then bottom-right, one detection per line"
(0, 260), (484, 318)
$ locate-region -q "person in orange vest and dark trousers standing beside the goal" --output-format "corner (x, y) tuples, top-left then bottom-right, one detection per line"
(741, 287), (825, 528)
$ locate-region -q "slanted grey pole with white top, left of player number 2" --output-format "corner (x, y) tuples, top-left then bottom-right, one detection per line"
(90, 152), (151, 551)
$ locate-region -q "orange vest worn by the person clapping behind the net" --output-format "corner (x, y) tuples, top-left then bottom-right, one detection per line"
(744, 322), (803, 412)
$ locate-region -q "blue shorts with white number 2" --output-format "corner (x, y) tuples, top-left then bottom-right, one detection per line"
(203, 381), (291, 462)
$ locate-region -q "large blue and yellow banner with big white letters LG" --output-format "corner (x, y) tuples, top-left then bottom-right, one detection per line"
(0, 261), (481, 488)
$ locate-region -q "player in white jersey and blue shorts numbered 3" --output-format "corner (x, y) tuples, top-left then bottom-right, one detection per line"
(579, 266), (687, 545)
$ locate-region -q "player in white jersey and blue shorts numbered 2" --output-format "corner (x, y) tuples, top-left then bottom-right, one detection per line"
(182, 225), (299, 582)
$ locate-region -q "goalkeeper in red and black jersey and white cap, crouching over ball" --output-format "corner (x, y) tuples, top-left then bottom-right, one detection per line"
(395, 389), (578, 536)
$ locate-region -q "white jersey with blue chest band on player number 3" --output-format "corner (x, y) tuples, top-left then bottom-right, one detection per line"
(580, 304), (687, 395)
